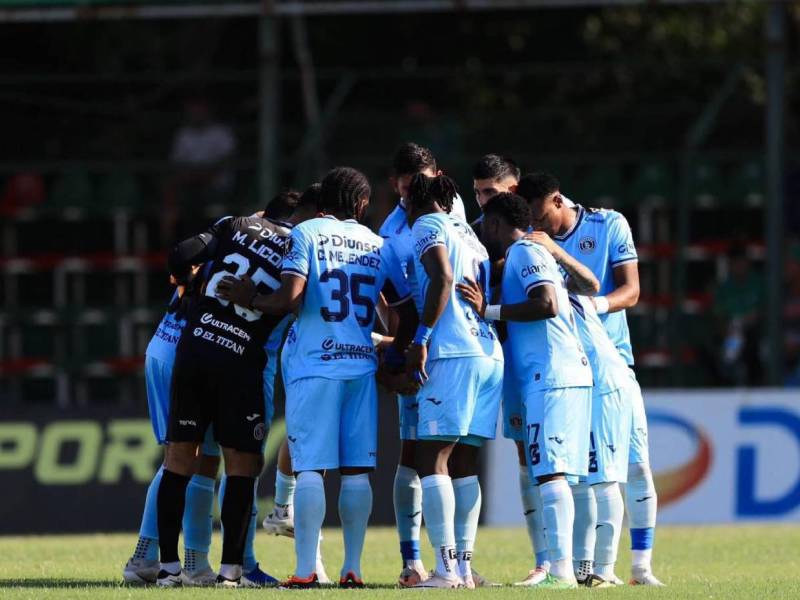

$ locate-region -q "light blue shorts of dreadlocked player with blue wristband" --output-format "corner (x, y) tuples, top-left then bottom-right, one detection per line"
(417, 356), (503, 440)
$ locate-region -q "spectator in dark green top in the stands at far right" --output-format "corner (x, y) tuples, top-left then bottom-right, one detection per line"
(714, 243), (764, 385)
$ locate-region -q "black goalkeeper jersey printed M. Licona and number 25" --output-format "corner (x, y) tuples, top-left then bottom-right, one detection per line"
(169, 217), (291, 368)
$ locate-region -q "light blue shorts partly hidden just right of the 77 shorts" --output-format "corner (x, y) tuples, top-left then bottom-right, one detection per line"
(587, 381), (636, 485)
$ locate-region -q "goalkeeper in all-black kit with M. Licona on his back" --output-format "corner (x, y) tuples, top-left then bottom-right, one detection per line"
(157, 206), (289, 586)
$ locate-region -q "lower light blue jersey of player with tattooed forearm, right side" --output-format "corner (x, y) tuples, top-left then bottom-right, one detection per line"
(569, 294), (631, 395)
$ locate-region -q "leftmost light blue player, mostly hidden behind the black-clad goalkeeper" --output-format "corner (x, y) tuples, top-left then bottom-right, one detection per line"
(122, 279), (220, 585)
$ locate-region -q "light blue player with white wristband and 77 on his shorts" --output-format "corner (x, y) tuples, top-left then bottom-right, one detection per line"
(459, 193), (592, 589)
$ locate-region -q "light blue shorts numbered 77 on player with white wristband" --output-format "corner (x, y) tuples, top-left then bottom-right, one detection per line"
(525, 387), (592, 478)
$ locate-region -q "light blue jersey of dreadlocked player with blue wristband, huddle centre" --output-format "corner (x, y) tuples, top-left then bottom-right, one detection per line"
(412, 213), (503, 360)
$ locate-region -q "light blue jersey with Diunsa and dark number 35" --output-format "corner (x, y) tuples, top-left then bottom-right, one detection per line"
(283, 216), (409, 384)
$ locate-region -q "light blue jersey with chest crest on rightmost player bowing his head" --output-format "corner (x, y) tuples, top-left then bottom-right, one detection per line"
(553, 204), (639, 365)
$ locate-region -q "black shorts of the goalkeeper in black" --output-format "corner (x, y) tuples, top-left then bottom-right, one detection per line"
(167, 353), (267, 454)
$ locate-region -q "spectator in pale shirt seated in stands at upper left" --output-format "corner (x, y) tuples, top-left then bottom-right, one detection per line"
(162, 98), (236, 241)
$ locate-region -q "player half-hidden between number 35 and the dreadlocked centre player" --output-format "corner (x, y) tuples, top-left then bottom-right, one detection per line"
(379, 143), (466, 587)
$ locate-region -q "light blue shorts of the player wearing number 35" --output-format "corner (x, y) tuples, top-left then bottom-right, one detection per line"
(286, 374), (378, 472)
